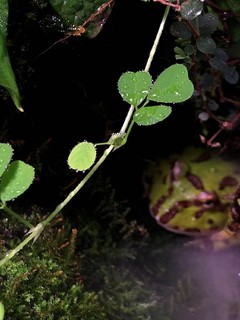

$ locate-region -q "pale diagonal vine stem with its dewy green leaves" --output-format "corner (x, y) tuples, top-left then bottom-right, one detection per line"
(0, 6), (193, 266)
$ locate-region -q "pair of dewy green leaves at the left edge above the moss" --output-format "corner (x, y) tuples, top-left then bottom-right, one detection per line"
(0, 143), (34, 203)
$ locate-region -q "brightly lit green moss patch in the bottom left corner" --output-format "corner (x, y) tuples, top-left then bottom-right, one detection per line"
(0, 219), (106, 320)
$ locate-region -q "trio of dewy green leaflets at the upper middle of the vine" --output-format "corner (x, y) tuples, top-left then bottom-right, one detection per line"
(118, 64), (194, 126)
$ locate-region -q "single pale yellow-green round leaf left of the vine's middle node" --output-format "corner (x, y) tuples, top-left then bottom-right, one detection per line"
(68, 141), (97, 171)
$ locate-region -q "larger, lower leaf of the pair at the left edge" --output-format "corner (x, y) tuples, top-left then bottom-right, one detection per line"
(0, 160), (34, 202)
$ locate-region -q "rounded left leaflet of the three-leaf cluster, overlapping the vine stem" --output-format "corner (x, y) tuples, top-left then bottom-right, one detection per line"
(118, 71), (152, 107)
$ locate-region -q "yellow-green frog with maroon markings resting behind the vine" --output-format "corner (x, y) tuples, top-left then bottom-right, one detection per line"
(144, 147), (240, 250)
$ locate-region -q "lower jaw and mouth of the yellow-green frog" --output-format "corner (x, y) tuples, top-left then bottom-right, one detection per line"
(151, 191), (230, 235)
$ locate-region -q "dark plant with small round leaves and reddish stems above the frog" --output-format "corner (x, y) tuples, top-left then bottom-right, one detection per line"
(170, 0), (240, 148)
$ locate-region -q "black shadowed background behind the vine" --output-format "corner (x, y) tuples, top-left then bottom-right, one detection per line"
(0, 0), (198, 219)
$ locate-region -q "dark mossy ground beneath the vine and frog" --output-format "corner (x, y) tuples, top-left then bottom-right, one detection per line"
(0, 179), (239, 320)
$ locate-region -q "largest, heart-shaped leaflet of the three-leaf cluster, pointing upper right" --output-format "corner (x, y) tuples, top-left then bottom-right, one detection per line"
(148, 64), (194, 103)
